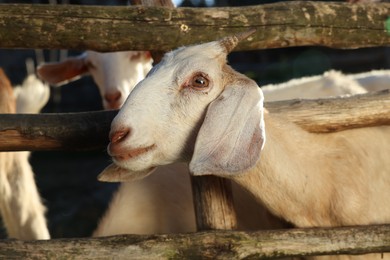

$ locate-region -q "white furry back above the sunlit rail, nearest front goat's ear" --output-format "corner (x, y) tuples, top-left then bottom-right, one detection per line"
(261, 70), (367, 101)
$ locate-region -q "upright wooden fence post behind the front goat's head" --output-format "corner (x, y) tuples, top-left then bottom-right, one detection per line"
(130, 0), (237, 231)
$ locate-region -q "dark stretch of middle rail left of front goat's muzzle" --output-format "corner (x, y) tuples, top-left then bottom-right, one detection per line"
(0, 111), (118, 151)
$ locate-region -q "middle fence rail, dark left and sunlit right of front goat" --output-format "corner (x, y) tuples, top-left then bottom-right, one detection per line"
(0, 90), (390, 151)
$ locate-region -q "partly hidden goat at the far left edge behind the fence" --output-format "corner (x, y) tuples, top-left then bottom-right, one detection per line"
(0, 69), (50, 240)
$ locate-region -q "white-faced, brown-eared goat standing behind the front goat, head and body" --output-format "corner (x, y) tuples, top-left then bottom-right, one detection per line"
(38, 39), (386, 240)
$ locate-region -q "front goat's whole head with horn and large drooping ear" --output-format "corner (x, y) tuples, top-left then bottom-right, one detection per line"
(101, 30), (264, 180)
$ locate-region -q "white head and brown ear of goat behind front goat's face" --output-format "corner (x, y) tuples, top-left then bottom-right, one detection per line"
(37, 51), (152, 109)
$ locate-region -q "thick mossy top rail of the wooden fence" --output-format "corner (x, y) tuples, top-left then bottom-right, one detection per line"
(0, 1), (390, 51)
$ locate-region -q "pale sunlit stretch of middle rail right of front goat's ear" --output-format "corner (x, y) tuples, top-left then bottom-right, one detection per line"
(265, 90), (390, 133)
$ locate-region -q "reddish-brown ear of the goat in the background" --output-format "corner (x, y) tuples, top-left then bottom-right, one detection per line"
(37, 55), (88, 85)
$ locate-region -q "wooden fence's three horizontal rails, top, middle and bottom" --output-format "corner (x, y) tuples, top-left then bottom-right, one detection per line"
(0, 2), (390, 259)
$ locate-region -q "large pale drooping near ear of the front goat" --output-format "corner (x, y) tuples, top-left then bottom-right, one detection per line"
(190, 78), (265, 177)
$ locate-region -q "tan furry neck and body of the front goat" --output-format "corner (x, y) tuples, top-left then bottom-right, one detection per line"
(235, 114), (390, 227)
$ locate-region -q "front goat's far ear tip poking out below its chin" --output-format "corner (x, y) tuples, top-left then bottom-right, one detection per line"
(97, 164), (155, 182)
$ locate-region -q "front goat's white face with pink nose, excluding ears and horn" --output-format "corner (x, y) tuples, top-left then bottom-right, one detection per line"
(108, 42), (226, 173)
